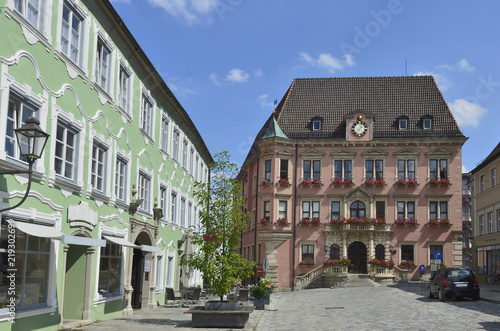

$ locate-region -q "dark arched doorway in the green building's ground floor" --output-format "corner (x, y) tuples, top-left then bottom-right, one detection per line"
(131, 232), (151, 309)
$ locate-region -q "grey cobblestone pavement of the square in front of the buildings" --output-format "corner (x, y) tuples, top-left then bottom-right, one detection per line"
(78, 283), (500, 331)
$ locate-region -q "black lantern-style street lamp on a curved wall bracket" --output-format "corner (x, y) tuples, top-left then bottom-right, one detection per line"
(0, 117), (50, 213)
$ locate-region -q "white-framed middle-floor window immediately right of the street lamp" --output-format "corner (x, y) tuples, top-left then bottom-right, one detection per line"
(54, 120), (77, 180)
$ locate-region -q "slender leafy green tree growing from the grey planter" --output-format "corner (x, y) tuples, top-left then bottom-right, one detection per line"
(180, 152), (255, 301)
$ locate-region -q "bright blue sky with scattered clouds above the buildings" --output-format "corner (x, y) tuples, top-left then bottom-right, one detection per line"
(111, 0), (500, 172)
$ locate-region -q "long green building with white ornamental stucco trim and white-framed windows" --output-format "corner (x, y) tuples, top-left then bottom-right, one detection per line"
(0, 0), (213, 330)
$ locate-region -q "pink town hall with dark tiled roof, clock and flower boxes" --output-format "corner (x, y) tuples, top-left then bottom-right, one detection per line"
(239, 76), (466, 290)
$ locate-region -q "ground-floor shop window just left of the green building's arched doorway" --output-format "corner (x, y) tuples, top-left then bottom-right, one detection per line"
(98, 243), (122, 297)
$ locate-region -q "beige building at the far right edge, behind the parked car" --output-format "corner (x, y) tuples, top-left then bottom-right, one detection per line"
(470, 144), (500, 279)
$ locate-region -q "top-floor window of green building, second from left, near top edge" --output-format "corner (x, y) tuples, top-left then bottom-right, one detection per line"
(61, 1), (83, 67)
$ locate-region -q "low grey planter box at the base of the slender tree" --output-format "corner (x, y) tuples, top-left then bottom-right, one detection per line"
(185, 306), (254, 329)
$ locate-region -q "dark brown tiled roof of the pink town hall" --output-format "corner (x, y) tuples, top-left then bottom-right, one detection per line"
(266, 76), (464, 139)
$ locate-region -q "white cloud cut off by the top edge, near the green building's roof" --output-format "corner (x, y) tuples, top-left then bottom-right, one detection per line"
(148, 0), (219, 25)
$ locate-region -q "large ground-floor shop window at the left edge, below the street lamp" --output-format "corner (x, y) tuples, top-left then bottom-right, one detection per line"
(0, 221), (50, 310)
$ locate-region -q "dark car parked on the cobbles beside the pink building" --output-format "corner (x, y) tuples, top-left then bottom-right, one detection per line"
(426, 268), (479, 301)
